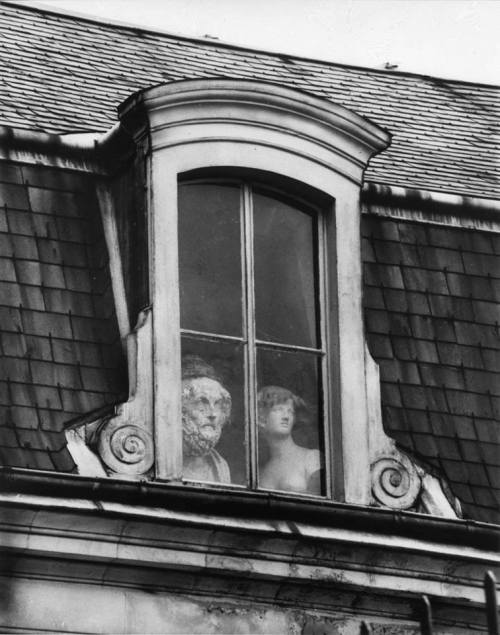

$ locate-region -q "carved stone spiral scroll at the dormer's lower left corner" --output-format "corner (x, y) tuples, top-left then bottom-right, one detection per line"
(98, 419), (154, 475)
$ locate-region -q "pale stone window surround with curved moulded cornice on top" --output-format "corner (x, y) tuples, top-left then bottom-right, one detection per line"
(119, 79), (389, 505)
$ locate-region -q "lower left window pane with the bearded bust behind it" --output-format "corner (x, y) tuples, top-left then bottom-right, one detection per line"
(182, 337), (247, 485)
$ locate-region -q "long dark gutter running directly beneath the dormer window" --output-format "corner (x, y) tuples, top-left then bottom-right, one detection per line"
(0, 467), (500, 551)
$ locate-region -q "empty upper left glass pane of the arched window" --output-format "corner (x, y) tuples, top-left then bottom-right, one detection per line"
(179, 184), (242, 336)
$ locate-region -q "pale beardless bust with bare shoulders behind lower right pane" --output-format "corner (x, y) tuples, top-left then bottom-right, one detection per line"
(257, 386), (321, 494)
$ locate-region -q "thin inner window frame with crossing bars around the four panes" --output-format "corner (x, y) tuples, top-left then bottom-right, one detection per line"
(178, 176), (339, 499)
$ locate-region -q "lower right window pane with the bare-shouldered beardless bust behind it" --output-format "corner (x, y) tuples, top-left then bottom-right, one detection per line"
(257, 348), (325, 495)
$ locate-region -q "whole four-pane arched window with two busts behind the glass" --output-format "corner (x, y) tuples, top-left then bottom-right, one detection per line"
(178, 178), (329, 495)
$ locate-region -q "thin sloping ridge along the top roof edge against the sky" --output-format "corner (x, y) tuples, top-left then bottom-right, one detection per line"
(0, 0), (500, 90)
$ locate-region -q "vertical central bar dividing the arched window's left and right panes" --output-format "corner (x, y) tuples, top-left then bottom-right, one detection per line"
(242, 185), (257, 489)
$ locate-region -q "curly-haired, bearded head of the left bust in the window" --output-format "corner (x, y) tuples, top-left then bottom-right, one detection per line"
(182, 377), (231, 456)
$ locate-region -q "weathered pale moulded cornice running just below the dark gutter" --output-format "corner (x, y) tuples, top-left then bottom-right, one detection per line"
(0, 494), (500, 606)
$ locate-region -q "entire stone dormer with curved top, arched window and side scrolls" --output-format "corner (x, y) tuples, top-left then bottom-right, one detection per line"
(63, 80), (455, 516)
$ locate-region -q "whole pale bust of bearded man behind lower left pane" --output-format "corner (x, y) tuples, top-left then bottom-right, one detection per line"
(182, 355), (231, 483)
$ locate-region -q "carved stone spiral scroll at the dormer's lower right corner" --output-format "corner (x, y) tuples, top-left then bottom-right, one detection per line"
(371, 455), (421, 509)
